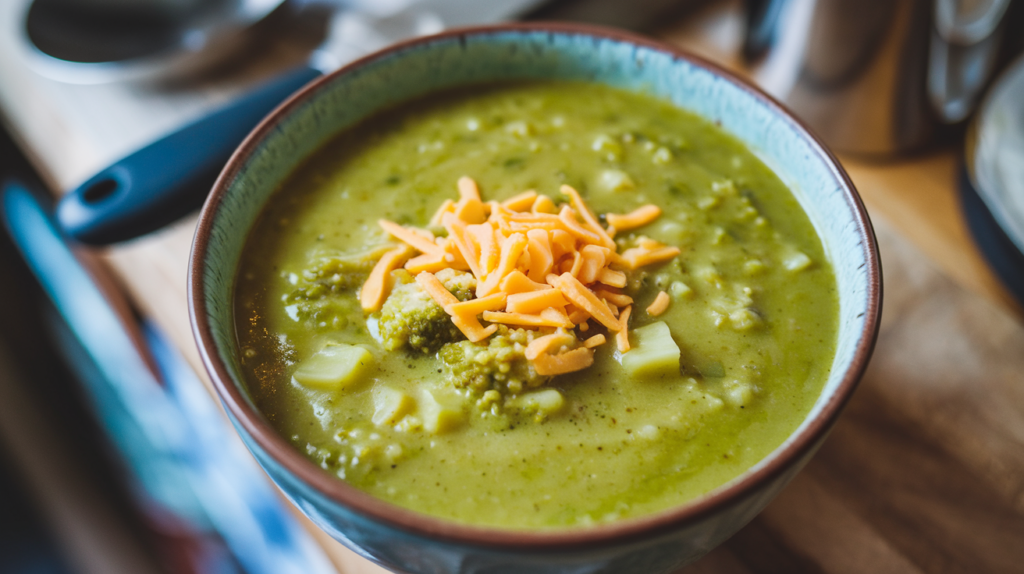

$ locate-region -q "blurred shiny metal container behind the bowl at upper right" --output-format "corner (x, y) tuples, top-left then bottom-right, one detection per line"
(744, 0), (1011, 154)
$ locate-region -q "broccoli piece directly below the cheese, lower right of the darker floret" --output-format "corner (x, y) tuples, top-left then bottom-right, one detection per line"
(437, 325), (551, 393)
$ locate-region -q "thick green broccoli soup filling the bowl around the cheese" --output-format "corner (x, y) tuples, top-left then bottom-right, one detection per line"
(236, 83), (839, 529)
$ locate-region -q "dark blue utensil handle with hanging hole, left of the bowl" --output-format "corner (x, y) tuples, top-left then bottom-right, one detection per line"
(56, 67), (321, 245)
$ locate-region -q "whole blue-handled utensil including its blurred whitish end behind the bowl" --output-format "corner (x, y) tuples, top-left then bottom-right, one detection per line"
(56, 0), (537, 245)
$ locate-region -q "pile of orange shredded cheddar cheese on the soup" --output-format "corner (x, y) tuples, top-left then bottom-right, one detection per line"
(359, 177), (680, 376)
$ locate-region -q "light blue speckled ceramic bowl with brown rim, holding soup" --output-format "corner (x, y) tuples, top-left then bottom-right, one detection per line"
(189, 25), (882, 574)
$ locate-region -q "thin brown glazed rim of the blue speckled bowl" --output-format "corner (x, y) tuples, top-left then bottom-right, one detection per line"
(188, 23), (882, 551)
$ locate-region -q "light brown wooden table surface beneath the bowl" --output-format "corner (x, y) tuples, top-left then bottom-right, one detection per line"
(0, 0), (1024, 574)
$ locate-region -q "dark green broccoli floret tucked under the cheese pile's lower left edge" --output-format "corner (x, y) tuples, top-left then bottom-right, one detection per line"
(378, 271), (476, 353)
